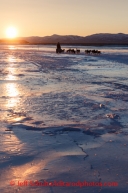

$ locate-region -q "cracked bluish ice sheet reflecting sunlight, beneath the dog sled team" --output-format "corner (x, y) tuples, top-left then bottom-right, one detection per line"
(0, 46), (128, 193)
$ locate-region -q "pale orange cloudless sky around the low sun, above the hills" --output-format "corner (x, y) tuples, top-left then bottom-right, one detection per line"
(0, 0), (128, 38)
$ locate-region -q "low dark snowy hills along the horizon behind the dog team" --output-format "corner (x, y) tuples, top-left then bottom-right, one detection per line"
(21, 33), (128, 44)
